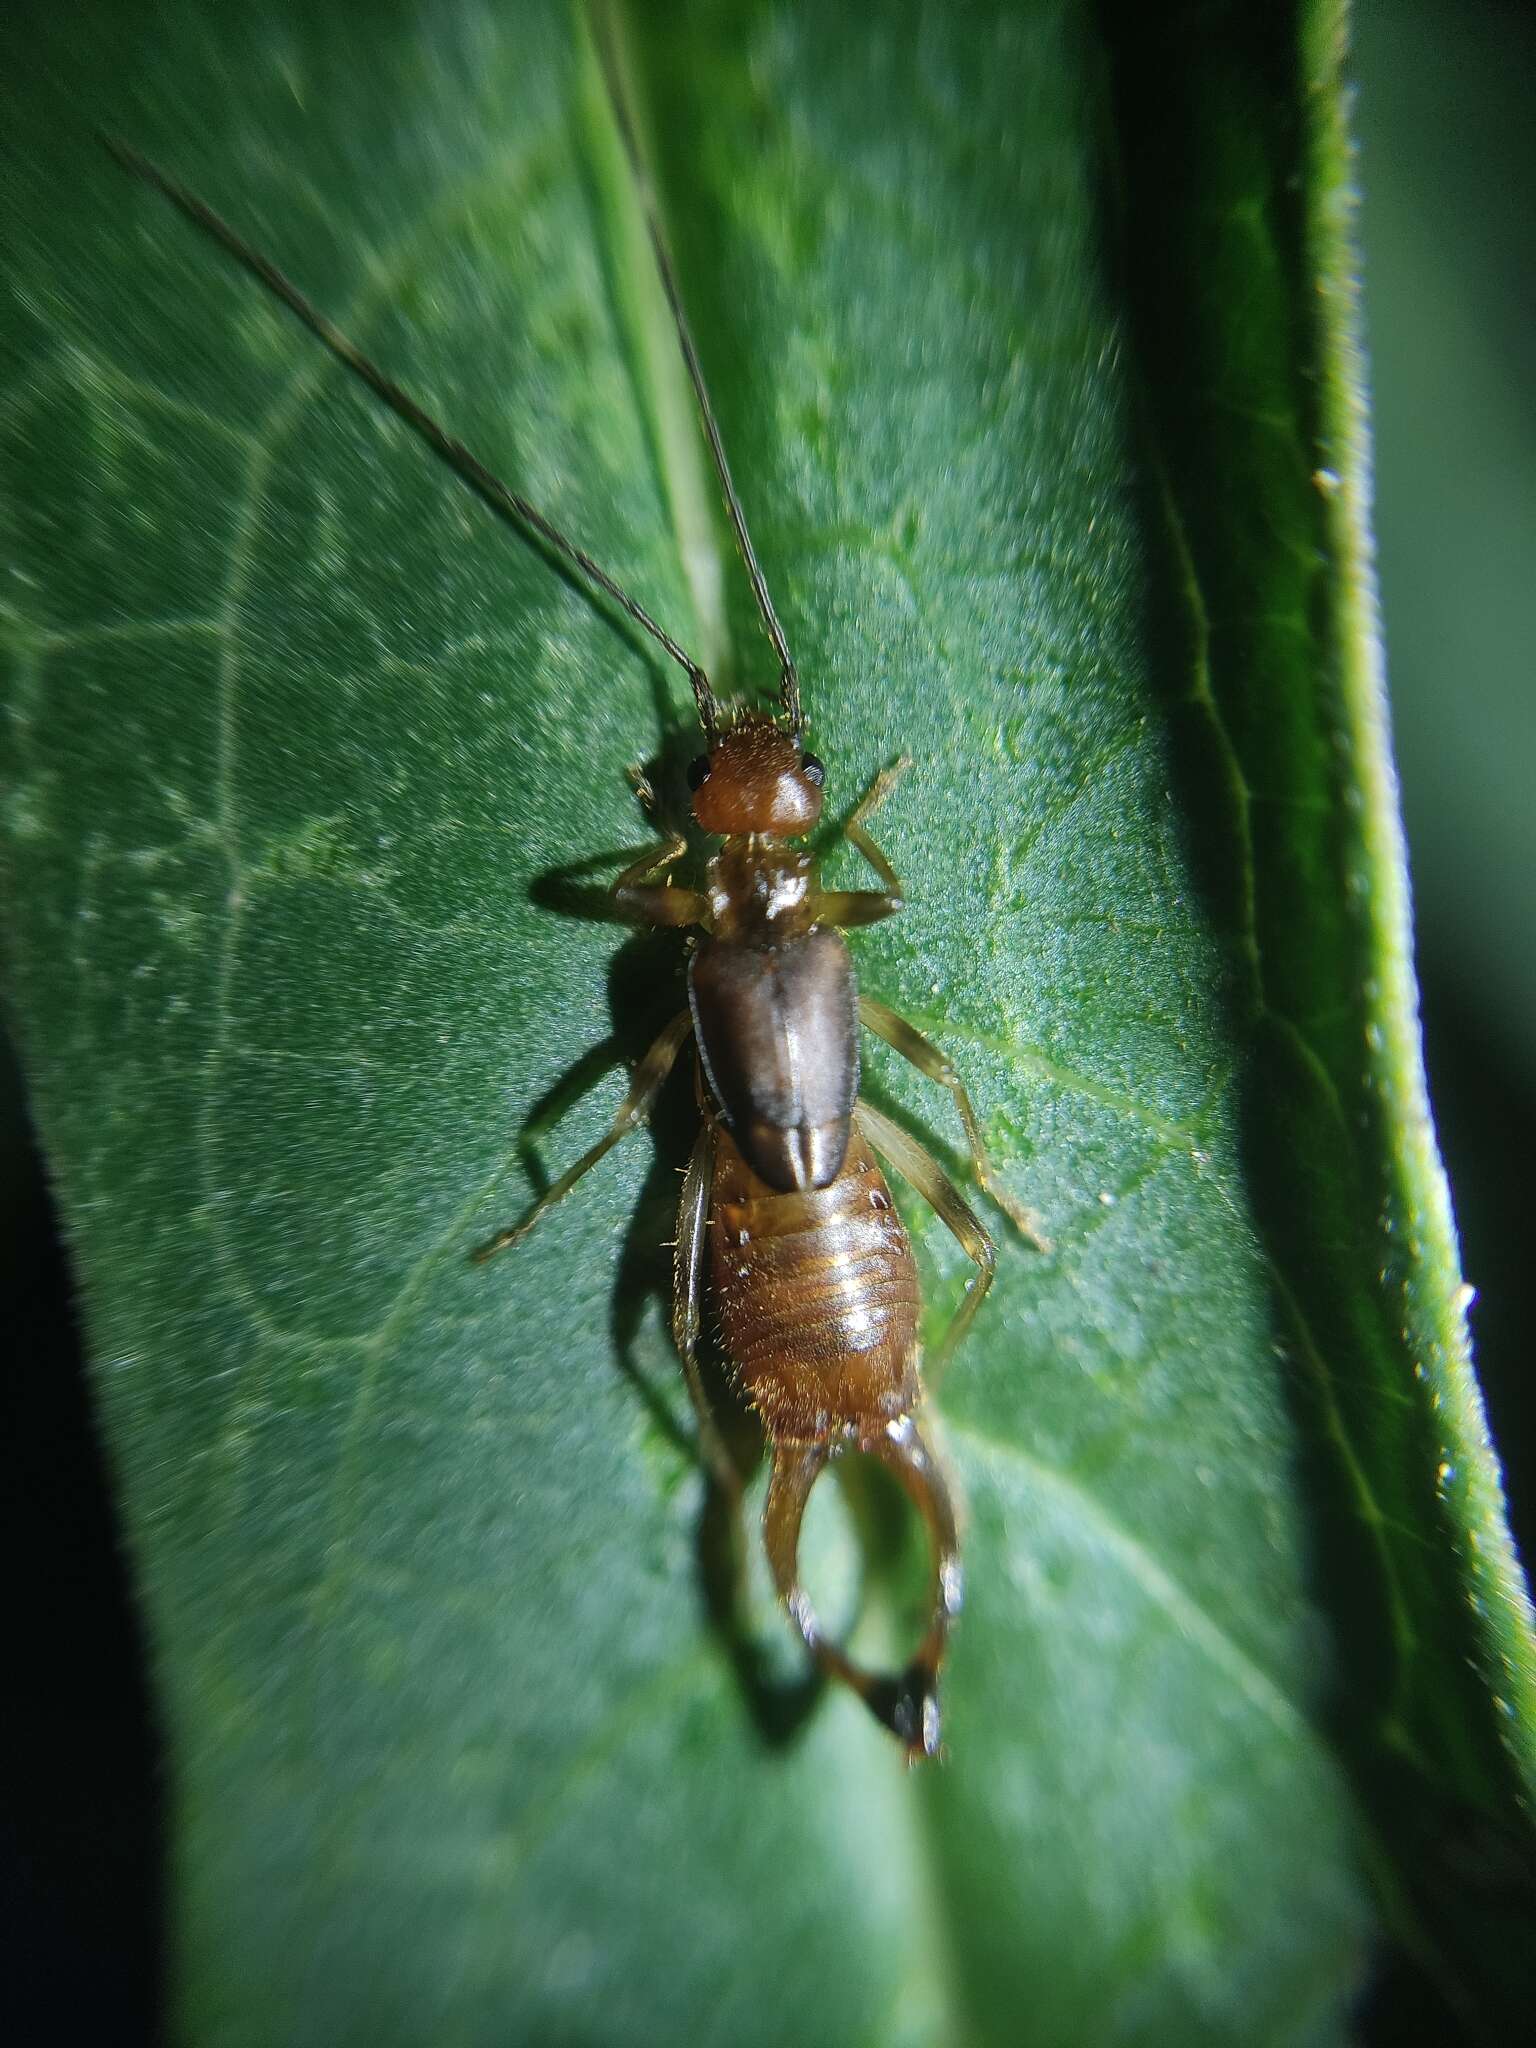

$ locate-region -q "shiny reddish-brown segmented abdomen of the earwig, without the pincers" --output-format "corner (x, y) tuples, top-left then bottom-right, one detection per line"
(709, 1126), (920, 1442)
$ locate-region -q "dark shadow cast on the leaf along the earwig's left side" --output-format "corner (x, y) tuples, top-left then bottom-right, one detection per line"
(516, 712), (823, 1749)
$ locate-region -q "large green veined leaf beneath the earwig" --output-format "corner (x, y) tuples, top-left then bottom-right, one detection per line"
(0, 0), (1536, 2048)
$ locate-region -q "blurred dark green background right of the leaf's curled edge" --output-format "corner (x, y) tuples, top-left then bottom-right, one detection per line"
(1354, 0), (1536, 1556)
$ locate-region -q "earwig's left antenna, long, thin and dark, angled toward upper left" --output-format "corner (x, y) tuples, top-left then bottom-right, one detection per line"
(100, 133), (721, 745)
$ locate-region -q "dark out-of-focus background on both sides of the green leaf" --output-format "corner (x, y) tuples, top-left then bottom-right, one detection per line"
(0, 0), (1536, 2048)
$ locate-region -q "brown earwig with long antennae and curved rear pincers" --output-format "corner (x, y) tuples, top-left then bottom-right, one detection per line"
(102, 64), (1042, 1759)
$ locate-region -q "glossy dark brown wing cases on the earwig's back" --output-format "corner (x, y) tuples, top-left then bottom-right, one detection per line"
(688, 926), (858, 1192)
